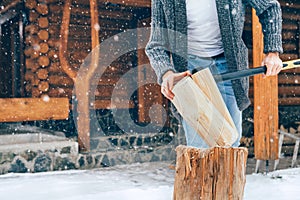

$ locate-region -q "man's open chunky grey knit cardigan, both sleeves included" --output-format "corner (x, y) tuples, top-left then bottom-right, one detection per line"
(146, 0), (282, 110)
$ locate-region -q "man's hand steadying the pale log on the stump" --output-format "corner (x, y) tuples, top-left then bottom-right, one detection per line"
(161, 71), (192, 100)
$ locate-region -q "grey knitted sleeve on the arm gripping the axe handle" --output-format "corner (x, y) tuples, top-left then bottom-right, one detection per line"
(249, 0), (283, 53)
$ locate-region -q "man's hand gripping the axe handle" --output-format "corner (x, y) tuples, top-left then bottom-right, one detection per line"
(262, 52), (282, 77)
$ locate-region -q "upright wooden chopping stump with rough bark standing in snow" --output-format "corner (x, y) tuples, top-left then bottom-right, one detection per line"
(173, 145), (248, 200)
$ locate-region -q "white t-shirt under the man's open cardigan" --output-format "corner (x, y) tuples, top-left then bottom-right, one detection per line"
(186, 0), (224, 57)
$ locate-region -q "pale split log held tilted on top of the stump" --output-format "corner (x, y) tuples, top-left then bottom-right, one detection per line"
(172, 69), (238, 147)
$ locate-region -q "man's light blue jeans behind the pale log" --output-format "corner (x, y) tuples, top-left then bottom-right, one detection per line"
(182, 55), (242, 148)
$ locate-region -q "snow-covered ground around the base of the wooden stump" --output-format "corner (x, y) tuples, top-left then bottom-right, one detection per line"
(0, 162), (300, 200)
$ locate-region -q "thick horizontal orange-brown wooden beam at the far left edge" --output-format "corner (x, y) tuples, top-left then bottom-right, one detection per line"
(0, 98), (69, 122)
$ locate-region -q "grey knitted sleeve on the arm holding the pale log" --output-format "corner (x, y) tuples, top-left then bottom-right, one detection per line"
(146, 0), (175, 84)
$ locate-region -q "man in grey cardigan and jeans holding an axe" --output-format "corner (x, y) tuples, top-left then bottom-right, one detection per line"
(146, 0), (282, 148)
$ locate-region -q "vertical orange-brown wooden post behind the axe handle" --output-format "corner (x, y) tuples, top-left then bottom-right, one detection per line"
(253, 10), (278, 160)
